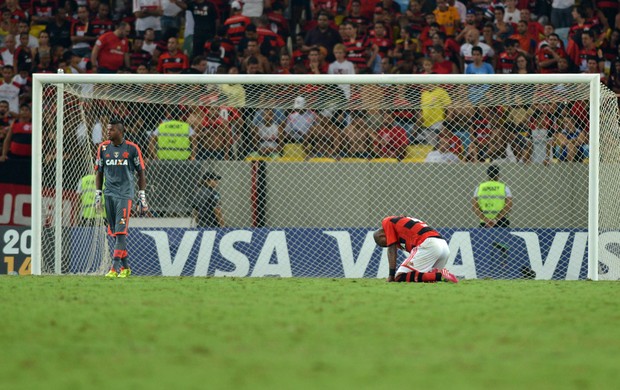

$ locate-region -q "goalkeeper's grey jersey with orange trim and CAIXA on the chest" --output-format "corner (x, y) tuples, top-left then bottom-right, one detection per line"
(95, 140), (144, 199)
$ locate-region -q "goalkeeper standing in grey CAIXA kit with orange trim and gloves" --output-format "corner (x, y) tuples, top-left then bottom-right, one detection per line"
(95, 119), (148, 278)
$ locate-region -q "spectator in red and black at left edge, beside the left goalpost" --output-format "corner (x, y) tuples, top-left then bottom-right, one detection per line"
(0, 104), (32, 162)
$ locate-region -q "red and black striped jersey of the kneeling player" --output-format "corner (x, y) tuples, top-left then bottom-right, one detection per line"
(381, 216), (441, 252)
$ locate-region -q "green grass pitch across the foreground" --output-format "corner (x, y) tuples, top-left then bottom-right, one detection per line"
(0, 276), (620, 389)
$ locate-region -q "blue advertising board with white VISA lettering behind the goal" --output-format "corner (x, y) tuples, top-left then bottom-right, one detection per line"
(70, 228), (620, 280)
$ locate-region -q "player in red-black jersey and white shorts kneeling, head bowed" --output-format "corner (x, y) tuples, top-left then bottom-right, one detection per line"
(374, 216), (458, 283)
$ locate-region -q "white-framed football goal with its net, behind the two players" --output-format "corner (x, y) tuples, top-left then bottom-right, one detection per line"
(32, 74), (620, 280)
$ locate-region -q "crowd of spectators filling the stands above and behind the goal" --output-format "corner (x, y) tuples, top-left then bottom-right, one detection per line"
(0, 0), (620, 166)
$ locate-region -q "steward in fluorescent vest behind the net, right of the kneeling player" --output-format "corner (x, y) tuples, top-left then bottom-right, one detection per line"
(472, 165), (512, 227)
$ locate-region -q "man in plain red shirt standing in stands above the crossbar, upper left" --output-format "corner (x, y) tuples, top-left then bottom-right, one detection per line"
(90, 22), (131, 73)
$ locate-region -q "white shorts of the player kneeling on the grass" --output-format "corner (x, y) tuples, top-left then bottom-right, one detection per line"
(396, 237), (450, 275)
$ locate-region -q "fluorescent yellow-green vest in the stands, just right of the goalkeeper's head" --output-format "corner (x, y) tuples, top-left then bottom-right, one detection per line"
(157, 120), (192, 160)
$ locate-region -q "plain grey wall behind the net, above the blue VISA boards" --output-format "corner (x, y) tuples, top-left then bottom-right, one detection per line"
(148, 161), (588, 229)
